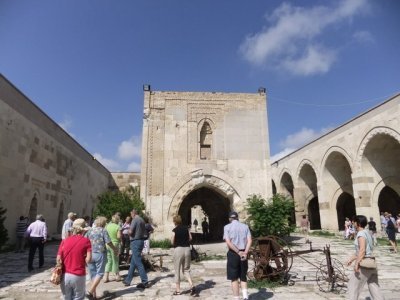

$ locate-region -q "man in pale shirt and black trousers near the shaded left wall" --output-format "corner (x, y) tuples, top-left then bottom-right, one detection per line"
(26, 215), (47, 272)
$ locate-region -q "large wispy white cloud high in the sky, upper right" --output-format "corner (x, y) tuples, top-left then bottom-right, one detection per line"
(240, 0), (367, 75)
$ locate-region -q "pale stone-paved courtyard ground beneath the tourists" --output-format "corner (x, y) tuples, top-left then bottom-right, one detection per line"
(0, 235), (400, 300)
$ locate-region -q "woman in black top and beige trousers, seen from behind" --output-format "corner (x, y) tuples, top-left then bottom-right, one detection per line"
(171, 216), (196, 296)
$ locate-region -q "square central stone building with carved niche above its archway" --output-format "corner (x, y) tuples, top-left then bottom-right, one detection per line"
(141, 88), (272, 240)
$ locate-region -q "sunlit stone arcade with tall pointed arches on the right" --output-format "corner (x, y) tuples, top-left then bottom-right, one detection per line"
(271, 94), (400, 230)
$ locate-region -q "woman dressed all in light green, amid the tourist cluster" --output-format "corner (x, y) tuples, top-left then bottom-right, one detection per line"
(104, 214), (121, 283)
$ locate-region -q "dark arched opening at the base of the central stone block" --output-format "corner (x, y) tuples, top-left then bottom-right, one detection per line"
(178, 187), (231, 241)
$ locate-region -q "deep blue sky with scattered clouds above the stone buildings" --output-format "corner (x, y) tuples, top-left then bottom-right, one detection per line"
(0, 0), (400, 171)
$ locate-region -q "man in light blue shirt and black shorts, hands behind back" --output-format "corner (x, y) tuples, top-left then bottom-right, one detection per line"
(224, 212), (252, 300)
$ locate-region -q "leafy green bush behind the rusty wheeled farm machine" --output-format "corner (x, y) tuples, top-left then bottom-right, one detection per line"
(246, 194), (295, 237)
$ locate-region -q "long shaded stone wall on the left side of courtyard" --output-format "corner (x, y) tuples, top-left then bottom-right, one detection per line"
(0, 75), (112, 243)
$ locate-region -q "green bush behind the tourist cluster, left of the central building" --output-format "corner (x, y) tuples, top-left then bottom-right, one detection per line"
(93, 187), (145, 219)
